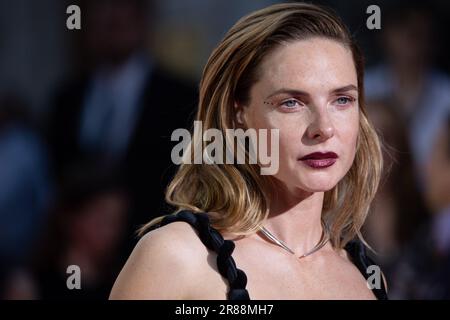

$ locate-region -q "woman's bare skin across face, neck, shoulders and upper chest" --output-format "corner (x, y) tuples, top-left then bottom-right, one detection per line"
(111, 38), (374, 299)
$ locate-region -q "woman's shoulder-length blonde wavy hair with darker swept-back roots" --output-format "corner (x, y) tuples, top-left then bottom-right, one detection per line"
(140, 3), (382, 248)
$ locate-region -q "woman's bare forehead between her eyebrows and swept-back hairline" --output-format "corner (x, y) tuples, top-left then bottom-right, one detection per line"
(258, 38), (357, 91)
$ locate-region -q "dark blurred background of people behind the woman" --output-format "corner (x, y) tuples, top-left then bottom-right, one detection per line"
(0, 0), (450, 299)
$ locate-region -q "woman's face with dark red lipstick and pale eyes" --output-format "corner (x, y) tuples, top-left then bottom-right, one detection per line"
(238, 38), (359, 193)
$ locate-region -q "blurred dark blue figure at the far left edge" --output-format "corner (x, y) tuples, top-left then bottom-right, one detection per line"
(0, 93), (52, 278)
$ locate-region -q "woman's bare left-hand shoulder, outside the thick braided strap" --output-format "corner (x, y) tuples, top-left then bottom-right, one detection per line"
(110, 221), (208, 300)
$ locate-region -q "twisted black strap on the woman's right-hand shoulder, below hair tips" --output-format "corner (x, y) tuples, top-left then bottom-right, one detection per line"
(345, 240), (388, 300)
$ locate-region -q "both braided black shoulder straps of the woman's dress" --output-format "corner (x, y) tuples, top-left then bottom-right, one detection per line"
(149, 210), (387, 300)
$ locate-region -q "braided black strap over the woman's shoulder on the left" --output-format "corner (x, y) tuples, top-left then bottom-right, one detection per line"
(150, 210), (250, 300)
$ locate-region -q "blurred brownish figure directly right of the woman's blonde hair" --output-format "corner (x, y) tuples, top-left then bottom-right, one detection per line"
(364, 100), (429, 283)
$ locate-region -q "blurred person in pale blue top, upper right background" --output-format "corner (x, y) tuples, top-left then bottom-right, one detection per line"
(365, 1), (450, 191)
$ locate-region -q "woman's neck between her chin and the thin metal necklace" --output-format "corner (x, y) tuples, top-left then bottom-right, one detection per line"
(264, 182), (324, 255)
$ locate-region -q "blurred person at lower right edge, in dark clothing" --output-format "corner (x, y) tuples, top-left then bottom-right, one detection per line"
(391, 114), (450, 299)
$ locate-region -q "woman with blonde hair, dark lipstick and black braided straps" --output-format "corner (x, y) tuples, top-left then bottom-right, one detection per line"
(110, 3), (386, 299)
